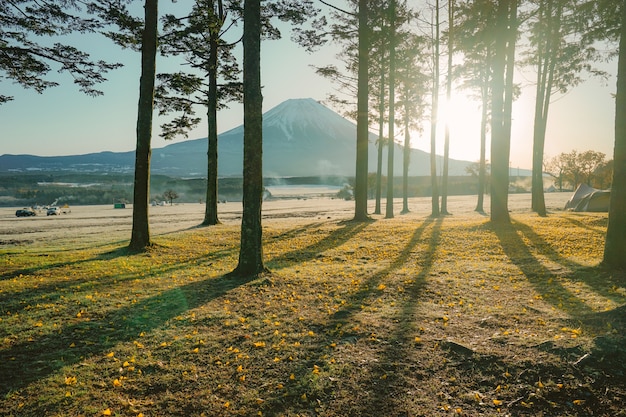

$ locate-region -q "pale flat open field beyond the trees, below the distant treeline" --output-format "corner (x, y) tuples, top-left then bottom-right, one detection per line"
(0, 193), (570, 247)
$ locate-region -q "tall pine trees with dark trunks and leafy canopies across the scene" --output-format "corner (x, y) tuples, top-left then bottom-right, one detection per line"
(0, 0), (626, 275)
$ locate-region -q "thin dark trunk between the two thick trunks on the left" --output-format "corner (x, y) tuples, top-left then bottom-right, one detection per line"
(202, 0), (223, 226)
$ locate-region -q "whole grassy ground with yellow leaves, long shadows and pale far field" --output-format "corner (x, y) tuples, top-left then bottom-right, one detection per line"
(0, 195), (626, 417)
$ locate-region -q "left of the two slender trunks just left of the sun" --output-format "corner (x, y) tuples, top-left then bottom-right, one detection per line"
(430, 0), (440, 217)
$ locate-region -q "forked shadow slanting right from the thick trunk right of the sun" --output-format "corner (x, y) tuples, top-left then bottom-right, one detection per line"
(489, 222), (592, 316)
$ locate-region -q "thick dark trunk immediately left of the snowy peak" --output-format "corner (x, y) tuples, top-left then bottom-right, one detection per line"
(233, 0), (266, 277)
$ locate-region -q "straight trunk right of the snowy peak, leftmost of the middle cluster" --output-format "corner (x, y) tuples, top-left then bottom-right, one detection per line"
(354, 0), (369, 221)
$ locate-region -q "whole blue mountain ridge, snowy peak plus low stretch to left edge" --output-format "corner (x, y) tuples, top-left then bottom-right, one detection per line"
(0, 98), (471, 177)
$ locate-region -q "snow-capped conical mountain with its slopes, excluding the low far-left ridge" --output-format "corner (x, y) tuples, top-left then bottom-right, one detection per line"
(153, 98), (470, 177)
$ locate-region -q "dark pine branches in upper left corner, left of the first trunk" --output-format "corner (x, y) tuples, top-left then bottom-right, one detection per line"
(0, 0), (120, 104)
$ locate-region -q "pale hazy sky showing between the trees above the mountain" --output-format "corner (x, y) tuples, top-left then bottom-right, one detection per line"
(0, 3), (616, 170)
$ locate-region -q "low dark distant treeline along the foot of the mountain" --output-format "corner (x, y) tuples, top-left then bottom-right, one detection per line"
(0, 172), (492, 207)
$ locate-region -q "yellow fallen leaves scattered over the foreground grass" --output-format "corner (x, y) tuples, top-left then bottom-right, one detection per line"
(5, 211), (626, 416)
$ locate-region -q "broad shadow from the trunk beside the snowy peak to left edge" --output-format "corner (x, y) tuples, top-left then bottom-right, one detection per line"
(0, 276), (250, 395)
